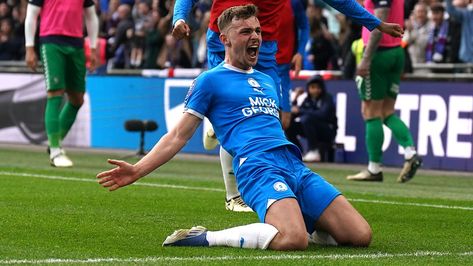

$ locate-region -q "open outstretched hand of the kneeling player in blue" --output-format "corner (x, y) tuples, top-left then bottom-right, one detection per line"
(97, 159), (140, 191)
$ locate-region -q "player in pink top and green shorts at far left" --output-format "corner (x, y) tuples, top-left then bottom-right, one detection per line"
(25, 0), (98, 167)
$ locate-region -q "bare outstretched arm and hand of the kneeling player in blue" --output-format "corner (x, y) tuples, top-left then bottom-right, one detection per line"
(97, 113), (202, 191)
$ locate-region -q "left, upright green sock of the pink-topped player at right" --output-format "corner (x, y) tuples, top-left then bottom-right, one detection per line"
(365, 117), (384, 163)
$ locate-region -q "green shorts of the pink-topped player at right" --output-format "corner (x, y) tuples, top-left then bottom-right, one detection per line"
(355, 47), (405, 101)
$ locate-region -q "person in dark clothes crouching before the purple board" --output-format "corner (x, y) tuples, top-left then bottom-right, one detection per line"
(286, 75), (338, 162)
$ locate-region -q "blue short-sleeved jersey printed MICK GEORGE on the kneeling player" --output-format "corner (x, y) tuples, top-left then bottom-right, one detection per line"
(185, 63), (293, 158)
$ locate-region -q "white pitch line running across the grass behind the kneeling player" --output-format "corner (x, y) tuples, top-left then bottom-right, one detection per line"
(0, 171), (473, 211)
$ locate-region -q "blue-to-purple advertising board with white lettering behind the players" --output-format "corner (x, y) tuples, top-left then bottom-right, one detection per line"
(87, 76), (473, 171)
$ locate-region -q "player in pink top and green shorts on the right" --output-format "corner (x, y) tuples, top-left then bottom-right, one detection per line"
(347, 0), (422, 183)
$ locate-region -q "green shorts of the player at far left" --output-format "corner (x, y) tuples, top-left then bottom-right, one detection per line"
(41, 43), (85, 92)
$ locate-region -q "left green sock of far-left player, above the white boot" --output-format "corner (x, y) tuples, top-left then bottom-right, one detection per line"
(44, 96), (62, 148)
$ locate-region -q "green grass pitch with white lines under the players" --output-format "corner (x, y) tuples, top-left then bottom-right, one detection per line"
(0, 146), (473, 265)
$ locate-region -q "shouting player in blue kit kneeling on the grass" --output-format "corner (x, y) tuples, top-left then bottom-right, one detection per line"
(97, 5), (380, 250)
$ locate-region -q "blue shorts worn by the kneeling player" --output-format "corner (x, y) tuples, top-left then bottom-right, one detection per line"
(233, 145), (341, 233)
